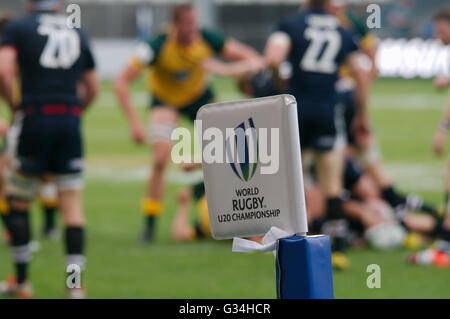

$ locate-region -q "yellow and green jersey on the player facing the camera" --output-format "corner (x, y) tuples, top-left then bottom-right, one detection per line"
(131, 29), (225, 108)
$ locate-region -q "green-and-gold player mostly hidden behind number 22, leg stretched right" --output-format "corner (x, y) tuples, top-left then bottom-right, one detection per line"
(332, 1), (438, 220)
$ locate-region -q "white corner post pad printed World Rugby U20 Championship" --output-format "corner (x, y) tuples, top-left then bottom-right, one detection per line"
(197, 94), (308, 242)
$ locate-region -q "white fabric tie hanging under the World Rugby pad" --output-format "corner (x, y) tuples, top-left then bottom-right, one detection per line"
(231, 227), (292, 255)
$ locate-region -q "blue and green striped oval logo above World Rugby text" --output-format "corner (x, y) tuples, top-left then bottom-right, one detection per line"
(226, 117), (259, 182)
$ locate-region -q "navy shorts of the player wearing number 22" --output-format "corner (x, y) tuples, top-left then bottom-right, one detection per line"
(297, 96), (345, 151)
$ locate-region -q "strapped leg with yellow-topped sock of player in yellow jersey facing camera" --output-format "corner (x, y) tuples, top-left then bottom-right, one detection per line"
(142, 107), (178, 242)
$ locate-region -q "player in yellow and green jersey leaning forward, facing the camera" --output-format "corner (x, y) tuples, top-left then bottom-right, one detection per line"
(114, 3), (260, 242)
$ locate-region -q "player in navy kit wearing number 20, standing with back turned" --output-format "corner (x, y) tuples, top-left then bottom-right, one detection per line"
(0, 0), (99, 298)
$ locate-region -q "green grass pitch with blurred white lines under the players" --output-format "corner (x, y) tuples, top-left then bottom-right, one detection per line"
(0, 79), (450, 298)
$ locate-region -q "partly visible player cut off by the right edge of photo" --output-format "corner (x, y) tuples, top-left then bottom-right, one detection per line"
(407, 10), (450, 267)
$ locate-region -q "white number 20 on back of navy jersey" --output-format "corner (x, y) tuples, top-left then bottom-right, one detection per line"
(38, 24), (80, 69)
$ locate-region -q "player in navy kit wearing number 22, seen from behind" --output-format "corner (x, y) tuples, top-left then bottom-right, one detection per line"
(265, 0), (368, 263)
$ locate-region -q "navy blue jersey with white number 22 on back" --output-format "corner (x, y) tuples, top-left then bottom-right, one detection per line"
(276, 10), (358, 99)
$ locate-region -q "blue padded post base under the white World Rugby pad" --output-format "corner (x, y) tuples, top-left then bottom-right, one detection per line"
(276, 235), (334, 299)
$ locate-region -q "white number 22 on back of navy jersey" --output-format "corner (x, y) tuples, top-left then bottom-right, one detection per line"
(300, 27), (341, 74)
